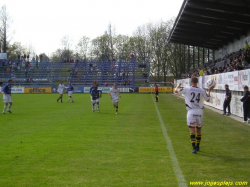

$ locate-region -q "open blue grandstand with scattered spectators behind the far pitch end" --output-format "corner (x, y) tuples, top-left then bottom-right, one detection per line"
(0, 55), (150, 87)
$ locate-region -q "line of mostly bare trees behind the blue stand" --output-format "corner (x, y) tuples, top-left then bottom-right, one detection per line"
(0, 6), (213, 82)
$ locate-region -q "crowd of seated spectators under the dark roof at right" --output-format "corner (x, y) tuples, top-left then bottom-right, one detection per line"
(182, 42), (250, 78)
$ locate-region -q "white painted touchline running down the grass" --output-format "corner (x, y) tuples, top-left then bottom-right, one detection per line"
(151, 94), (187, 187)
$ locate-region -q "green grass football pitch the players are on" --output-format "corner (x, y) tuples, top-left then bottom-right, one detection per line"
(0, 94), (250, 187)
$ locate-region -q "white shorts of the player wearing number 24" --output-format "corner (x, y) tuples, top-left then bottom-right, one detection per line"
(187, 109), (204, 127)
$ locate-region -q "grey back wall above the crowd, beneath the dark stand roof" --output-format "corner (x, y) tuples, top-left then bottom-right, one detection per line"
(214, 32), (250, 59)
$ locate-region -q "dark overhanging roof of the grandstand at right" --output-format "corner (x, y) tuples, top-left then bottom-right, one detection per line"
(168, 0), (250, 49)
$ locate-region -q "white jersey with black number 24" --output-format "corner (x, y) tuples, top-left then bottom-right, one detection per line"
(179, 86), (210, 110)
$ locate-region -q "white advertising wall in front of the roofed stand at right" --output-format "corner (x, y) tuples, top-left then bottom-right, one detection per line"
(175, 70), (250, 117)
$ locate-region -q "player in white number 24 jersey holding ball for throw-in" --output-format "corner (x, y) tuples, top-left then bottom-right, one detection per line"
(175, 77), (214, 153)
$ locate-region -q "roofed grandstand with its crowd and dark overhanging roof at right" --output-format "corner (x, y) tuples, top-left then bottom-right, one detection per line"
(168, 0), (250, 78)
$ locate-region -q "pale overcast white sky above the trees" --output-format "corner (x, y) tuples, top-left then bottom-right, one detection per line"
(0, 0), (183, 55)
